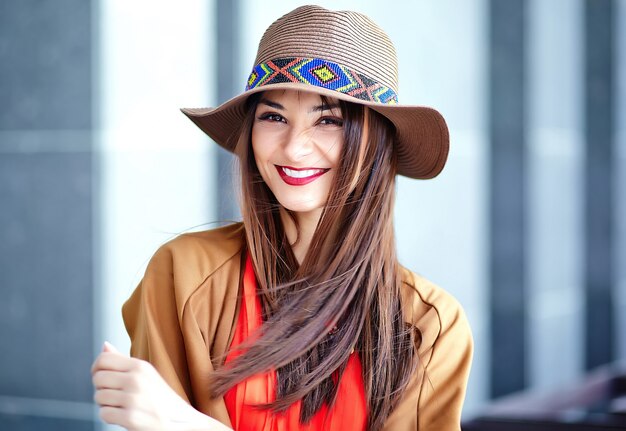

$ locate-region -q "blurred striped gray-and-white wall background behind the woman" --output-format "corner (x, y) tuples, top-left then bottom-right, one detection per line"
(0, 0), (626, 431)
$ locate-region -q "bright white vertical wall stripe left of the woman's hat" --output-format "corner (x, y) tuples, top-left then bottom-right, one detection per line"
(97, 8), (215, 430)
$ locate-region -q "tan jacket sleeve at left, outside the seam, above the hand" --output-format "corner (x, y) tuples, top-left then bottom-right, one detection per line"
(122, 247), (192, 402)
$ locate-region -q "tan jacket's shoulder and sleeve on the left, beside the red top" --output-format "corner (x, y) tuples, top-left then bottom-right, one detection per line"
(122, 224), (245, 384)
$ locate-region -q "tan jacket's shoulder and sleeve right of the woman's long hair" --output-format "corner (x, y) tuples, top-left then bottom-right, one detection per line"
(386, 268), (474, 430)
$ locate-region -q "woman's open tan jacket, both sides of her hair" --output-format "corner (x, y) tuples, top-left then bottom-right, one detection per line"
(122, 224), (473, 431)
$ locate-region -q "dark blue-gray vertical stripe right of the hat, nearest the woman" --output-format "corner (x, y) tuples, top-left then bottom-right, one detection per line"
(488, 0), (526, 397)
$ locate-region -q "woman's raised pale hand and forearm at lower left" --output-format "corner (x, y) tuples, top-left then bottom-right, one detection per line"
(91, 343), (230, 431)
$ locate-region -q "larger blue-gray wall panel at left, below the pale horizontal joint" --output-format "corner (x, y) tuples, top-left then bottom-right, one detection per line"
(0, 152), (93, 401)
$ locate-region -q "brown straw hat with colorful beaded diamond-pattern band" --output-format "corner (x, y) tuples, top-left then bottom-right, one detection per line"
(182, 6), (449, 179)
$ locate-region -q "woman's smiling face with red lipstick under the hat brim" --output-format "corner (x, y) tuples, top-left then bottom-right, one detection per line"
(252, 90), (344, 213)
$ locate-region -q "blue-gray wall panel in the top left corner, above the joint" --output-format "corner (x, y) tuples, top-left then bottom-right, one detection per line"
(0, 0), (92, 130)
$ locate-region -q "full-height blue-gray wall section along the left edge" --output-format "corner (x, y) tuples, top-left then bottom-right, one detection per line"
(0, 0), (96, 430)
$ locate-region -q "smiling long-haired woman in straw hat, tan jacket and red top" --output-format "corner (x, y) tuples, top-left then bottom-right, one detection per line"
(92, 6), (472, 431)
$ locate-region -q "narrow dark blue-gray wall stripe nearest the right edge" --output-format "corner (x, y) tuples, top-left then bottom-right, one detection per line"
(584, 0), (615, 369)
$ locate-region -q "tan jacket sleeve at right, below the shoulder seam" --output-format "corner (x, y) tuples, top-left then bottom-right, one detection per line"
(417, 302), (473, 431)
